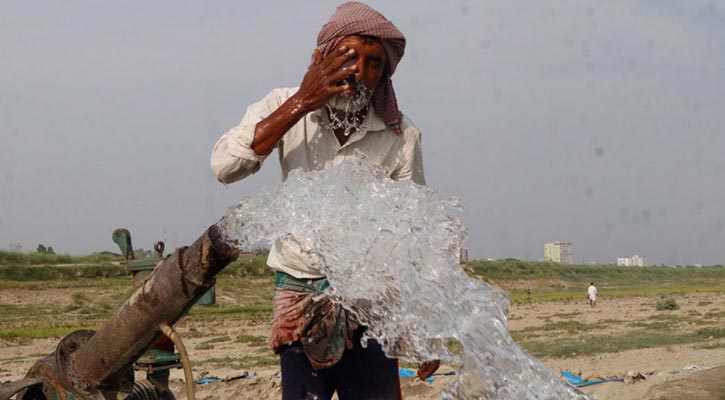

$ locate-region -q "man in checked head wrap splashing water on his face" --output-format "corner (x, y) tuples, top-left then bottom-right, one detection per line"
(211, 2), (438, 400)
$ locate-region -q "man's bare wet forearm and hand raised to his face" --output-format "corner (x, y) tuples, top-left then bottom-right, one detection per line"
(252, 46), (357, 156)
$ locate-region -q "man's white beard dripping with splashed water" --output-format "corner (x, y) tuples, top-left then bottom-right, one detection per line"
(325, 81), (373, 136)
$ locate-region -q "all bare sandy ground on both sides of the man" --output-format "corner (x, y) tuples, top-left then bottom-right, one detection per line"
(0, 287), (725, 400)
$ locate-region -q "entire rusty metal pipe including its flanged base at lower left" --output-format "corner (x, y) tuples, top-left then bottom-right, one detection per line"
(0, 225), (239, 400)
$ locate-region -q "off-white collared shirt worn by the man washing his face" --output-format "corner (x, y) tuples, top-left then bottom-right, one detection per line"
(211, 88), (425, 279)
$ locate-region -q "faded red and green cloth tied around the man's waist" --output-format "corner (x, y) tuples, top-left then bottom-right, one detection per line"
(269, 272), (361, 370)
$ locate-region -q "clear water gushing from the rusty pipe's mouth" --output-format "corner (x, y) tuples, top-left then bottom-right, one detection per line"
(221, 159), (591, 400)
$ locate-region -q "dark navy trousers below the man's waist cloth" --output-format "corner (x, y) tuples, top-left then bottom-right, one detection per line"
(279, 337), (400, 400)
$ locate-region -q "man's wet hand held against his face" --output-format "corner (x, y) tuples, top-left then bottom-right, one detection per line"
(295, 46), (357, 111)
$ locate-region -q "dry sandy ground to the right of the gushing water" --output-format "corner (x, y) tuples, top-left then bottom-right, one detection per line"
(509, 293), (725, 400)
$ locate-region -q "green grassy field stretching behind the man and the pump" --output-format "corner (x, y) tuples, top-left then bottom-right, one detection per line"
(0, 252), (725, 365)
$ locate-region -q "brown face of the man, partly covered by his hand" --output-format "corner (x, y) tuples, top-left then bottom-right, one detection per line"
(330, 35), (387, 96)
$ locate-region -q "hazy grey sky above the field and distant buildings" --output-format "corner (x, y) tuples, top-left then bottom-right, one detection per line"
(0, 0), (725, 265)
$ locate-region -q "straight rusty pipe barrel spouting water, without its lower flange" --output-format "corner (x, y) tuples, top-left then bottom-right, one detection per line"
(73, 225), (239, 394)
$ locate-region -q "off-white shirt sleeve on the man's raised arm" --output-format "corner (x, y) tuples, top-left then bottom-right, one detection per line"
(211, 89), (289, 183)
